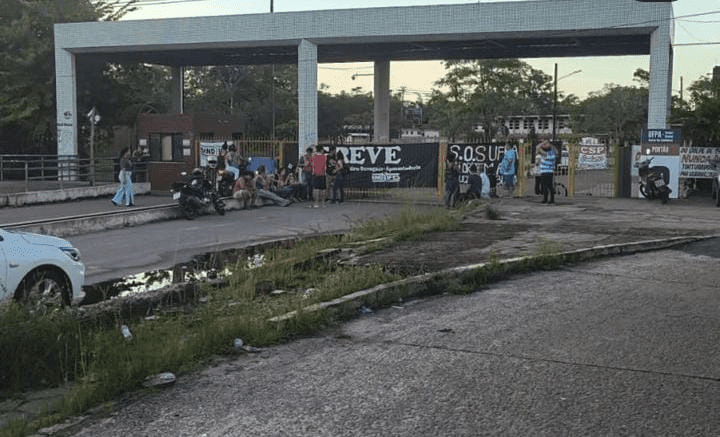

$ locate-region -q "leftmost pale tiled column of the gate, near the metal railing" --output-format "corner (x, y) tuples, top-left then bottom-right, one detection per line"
(55, 48), (77, 158)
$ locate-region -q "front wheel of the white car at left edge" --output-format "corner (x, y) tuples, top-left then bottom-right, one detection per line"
(19, 270), (71, 308)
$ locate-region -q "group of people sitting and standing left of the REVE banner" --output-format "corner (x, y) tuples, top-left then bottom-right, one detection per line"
(223, 142), (349, 207)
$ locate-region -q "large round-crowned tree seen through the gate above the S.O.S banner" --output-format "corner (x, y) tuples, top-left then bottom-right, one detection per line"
(430, 59), (552, 141)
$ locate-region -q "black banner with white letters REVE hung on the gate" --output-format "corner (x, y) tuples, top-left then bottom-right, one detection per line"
(337, 143), (438, 187)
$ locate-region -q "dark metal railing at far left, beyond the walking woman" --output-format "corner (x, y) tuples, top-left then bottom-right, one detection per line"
(0, 155), (147, 191)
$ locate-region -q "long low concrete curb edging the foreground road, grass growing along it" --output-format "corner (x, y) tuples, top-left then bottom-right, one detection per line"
(269, 235), (719, 323)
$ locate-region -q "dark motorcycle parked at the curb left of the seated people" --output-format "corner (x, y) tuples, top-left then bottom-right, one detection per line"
(170, 169), (225, 220)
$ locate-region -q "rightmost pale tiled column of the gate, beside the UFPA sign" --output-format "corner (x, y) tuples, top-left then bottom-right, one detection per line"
(648, 20), (673, 129)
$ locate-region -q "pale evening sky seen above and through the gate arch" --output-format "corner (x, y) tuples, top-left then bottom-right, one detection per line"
(124, 0), (720, 100)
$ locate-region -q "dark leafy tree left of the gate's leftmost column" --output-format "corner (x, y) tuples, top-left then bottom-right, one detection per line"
(0, 0), (138, 153)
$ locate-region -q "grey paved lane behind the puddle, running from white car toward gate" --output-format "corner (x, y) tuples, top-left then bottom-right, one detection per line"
(68, 200), (422, 284)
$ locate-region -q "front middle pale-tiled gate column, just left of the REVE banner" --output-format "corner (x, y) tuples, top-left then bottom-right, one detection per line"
(298, 39), (318, 159)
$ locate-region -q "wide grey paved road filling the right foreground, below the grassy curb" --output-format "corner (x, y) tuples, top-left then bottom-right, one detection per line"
(71, 244), (720, 437)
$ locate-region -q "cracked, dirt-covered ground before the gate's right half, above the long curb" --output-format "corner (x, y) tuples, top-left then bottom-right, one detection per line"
(356, 197), (718, 275)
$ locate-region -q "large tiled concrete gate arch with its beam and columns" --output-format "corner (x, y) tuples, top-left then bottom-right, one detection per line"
(55, 0), (674, 156)
